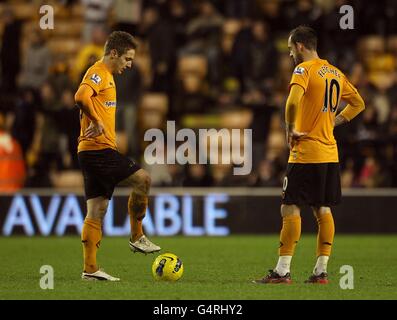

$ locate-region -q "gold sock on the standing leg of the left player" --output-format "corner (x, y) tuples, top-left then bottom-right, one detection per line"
(81, 218), (102, 273)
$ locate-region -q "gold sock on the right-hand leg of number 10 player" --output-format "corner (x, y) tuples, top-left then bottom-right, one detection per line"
(316, 212), (335, 257)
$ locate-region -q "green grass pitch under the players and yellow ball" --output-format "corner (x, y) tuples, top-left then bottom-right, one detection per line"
(0, 234), (397, 300)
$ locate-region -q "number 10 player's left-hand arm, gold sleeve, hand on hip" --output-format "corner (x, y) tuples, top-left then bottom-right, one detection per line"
(285, 84), (306, 149)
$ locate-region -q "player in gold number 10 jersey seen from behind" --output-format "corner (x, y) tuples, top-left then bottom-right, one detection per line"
(255, 26), (365, 284)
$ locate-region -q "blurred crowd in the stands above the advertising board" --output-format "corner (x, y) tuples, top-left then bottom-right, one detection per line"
(0, 0), (397, 191)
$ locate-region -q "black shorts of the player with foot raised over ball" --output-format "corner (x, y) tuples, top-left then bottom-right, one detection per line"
(78, 148), (141, 200)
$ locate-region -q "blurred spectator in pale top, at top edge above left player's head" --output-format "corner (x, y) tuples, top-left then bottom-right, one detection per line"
(81, 0), (114, 43)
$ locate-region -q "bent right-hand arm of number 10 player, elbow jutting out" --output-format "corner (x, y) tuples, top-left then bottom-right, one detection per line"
(335, 79), (365, 126)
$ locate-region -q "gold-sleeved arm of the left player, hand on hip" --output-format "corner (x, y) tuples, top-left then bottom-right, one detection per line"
(74, 83), (104, 138)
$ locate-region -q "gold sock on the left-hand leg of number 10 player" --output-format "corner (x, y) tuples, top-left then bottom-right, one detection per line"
(278, 215), (301, 256)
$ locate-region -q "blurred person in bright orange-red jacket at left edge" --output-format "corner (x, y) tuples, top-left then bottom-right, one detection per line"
(0, 113), (26, 192)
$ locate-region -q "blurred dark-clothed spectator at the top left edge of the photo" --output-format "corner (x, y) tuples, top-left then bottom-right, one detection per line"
(0, 7), (21, 95)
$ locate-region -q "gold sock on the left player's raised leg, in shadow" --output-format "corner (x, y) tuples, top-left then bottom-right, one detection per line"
(128, 193), (148, 241)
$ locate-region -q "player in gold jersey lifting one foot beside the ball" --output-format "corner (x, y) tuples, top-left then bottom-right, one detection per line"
(75, 31), (160, 281)
